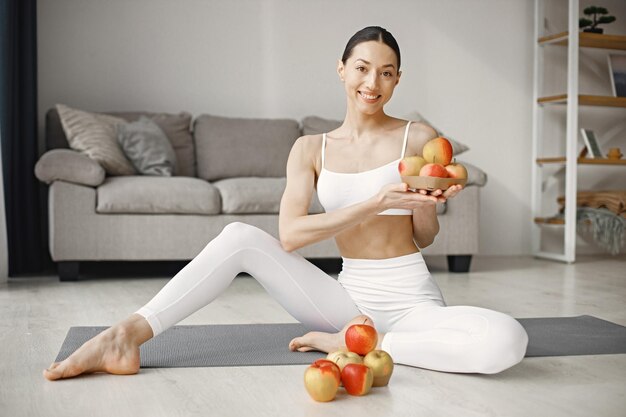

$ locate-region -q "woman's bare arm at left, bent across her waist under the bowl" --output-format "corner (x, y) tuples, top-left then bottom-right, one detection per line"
(278, 136), (437, 252)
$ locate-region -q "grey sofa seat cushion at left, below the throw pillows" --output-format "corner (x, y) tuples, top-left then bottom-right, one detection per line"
(96, 175), (220, 214)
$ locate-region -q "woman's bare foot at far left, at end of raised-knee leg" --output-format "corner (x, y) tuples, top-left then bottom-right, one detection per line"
(43, 315), (152, 381)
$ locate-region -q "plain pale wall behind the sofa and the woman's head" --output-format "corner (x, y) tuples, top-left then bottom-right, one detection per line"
(37, 0), (620, 255)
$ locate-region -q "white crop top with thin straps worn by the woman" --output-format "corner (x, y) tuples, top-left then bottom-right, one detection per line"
(317, 122), (413, 216)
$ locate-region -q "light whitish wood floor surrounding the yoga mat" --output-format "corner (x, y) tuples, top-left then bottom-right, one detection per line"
(0, 257), (626, 417)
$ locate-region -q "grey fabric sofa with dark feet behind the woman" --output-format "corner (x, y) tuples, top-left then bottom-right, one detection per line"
(35, 109), (479, 280)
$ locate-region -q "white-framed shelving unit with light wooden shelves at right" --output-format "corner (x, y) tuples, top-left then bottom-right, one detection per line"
(531, 0), (626, 262)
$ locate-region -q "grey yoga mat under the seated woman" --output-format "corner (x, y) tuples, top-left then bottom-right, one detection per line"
(56, 316), (626, 368)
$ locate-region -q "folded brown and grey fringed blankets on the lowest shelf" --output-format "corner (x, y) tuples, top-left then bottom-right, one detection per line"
(557, 190), (626, 255)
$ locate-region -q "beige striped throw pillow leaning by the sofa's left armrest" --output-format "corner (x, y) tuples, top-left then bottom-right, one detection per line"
(56, 104), (136, 175)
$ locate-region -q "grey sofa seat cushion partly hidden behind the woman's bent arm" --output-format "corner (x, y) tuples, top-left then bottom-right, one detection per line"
(213, 177), (324, 214)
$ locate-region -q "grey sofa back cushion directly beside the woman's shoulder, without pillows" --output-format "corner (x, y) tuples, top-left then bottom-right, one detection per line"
(194, 115), (300, 181)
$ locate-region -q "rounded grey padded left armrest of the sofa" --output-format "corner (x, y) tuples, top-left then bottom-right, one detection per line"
(35, 149), (105, 187)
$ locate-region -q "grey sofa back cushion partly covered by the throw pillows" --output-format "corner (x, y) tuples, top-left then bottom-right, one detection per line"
(107, 112), (196, 177)
